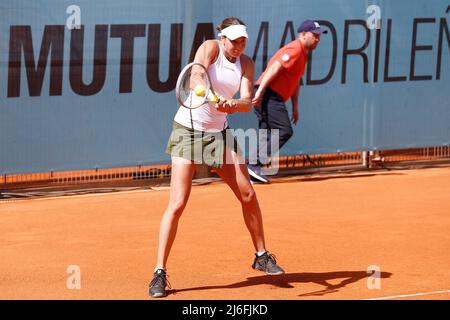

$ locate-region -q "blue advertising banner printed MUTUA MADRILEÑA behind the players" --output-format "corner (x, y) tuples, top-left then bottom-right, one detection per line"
(0, 0), (450, 174)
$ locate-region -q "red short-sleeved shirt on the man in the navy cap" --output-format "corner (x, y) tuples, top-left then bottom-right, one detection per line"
(256, 39), (308, 101)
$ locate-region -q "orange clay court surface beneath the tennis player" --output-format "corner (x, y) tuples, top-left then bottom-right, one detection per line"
(0, 167), (450, 300)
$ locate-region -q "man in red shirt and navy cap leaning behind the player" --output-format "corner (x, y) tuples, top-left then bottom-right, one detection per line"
(248, 20), (327, 183)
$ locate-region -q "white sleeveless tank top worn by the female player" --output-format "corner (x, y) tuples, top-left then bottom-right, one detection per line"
(174, 45), (242, 132)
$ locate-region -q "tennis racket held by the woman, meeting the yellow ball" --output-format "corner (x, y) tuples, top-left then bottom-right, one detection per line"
(175, 62), (220, 109)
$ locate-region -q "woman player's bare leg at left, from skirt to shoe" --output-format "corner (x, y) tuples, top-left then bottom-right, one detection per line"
(156, 157), (195, 269)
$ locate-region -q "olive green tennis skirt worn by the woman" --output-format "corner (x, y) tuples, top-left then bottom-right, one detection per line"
(166, 121), (241, 168)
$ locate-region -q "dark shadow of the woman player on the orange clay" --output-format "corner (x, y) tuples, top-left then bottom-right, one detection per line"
(169, 271), (392, 297)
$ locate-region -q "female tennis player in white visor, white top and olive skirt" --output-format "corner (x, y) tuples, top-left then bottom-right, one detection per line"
(149, 17), (284, 297)
